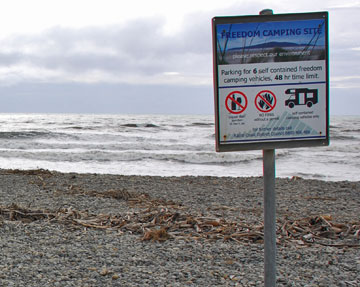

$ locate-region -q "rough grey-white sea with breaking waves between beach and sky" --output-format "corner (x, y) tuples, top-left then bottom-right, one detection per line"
(0, 114), (360, 181)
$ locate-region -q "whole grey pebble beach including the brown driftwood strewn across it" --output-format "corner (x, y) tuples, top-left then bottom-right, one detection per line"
(0, 170), (360, 286)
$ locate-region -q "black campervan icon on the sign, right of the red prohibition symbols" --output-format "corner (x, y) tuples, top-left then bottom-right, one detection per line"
(285, 88), (318, 108)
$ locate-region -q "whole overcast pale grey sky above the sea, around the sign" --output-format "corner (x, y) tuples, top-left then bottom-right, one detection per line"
(0, 0), (360, 115)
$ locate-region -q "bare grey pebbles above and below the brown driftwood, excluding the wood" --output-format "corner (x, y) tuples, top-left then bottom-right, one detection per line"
(0, 171), (360, 287)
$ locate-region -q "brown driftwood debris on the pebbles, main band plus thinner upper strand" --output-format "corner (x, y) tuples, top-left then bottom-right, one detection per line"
(0, 170), (360, 248)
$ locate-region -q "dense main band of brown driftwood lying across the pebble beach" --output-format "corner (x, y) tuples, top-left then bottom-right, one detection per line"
(0, 200), (360, 247)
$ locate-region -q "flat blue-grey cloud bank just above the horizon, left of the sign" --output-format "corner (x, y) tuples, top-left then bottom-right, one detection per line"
(0, 83), (213, 114)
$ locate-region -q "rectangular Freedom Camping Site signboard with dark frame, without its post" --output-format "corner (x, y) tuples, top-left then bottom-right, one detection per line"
(213, 12), (329, 151)
